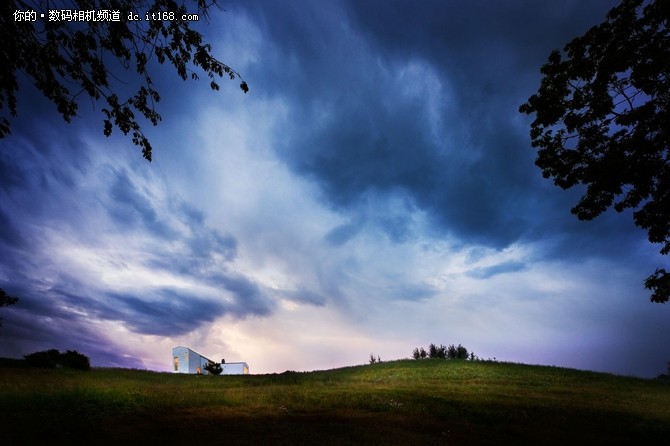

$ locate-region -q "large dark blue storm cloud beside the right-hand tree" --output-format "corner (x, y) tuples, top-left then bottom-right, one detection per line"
(240, 1), (624, 248)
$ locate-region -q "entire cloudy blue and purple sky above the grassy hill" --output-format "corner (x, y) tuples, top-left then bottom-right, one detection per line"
(0, 0), (670, 377)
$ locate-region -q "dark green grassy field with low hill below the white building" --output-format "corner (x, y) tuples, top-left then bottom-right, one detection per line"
(0, 360), (670, 445)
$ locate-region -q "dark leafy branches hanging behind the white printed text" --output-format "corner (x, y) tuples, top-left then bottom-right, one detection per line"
(0, 0), (249, 161)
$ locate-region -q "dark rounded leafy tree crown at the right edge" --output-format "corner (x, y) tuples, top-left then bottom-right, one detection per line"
(519, 0), (670, 303)
